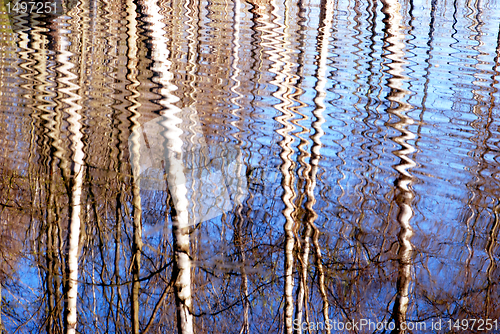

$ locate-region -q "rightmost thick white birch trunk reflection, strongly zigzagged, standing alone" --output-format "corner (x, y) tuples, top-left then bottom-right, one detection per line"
(382, 0), (415, 332)
